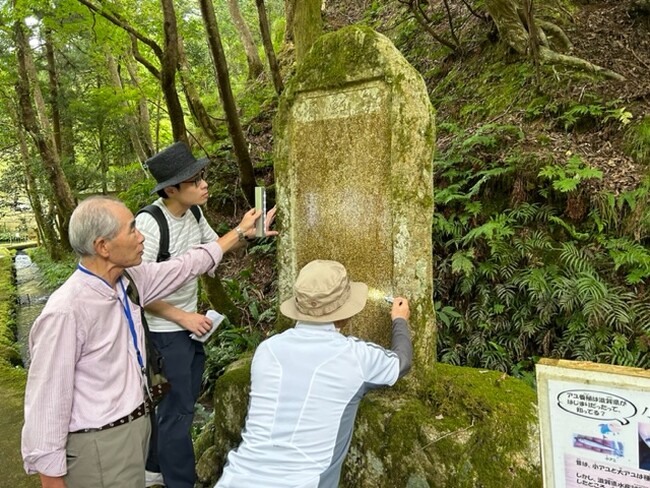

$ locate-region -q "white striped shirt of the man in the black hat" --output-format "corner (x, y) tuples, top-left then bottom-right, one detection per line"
(135, 198), (219, 332)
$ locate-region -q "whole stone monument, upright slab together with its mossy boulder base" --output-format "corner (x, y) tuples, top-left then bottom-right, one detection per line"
(195, 26), (542, 488)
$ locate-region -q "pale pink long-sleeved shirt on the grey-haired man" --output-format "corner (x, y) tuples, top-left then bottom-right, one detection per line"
(22, 242), (223, 476)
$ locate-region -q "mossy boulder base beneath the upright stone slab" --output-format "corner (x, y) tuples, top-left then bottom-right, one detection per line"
(197, 359), (542, 488)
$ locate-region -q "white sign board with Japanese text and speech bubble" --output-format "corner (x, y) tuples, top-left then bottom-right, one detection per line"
(536, 359), (650, 488)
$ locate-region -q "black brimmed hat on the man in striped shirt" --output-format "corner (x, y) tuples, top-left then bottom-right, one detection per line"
(144, 142), (210, 193)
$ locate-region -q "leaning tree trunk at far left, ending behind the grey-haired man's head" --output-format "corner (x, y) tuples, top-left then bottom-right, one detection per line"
(14, 16), (75, 254)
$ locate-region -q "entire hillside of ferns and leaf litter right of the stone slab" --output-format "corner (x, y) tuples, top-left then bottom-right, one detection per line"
(318, 0), (650, 382)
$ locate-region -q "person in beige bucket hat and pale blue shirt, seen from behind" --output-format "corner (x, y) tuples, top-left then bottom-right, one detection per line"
(215, 260), (413, 488)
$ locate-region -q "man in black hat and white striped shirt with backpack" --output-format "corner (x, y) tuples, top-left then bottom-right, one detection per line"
(136, 142), (277, 488)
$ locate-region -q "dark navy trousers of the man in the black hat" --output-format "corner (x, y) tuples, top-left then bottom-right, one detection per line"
(147, 331), (205, 488)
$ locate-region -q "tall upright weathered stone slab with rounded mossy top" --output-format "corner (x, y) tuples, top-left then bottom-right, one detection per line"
(274, 26), (435, 370)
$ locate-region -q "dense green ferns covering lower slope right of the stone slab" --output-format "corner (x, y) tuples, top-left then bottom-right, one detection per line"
(433, 119), (650, 382)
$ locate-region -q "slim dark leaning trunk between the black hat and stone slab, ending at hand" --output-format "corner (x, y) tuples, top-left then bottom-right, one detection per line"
(199, 0), (255, 206)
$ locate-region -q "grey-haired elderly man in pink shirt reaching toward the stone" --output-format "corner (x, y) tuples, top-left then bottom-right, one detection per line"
(22, 197), (261, 488)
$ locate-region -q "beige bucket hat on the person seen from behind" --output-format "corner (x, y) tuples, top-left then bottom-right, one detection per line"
(280, 259), (368, 323)
